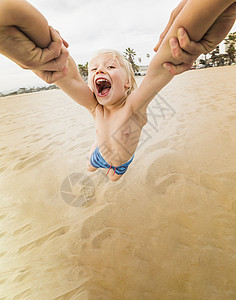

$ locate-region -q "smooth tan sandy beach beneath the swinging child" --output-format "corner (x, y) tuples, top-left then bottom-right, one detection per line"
(0, 66), (236, 300)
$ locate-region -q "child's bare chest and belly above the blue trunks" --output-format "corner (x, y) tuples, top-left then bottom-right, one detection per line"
(95, 105), (146, 166)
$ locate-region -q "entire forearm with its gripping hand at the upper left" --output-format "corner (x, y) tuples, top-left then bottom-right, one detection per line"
(0, 0), (68, 71)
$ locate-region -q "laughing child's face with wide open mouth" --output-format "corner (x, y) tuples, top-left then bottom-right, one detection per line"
(89, 53), (129, 105)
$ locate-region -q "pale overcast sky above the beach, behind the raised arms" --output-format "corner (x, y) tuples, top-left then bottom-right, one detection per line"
(0, 0), (236, 92)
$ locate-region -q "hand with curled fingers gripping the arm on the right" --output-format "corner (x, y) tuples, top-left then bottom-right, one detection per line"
(163, 28), (205, 75)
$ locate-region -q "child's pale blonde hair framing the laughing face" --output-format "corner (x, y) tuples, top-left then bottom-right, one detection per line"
(88, 49), (137, 98)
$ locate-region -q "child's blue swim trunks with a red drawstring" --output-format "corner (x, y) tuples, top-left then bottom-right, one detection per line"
(90, 147), (134, 175)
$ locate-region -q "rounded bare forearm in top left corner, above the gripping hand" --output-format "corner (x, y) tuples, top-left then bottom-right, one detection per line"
(0, 0), (51, 48)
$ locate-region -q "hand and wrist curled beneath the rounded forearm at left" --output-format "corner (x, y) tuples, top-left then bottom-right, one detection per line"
(0, 26), (69, 71)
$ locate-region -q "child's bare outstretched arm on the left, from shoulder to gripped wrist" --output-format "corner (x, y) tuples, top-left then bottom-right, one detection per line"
(35, 57), (98, 115)
